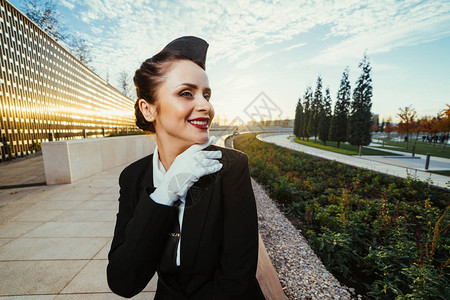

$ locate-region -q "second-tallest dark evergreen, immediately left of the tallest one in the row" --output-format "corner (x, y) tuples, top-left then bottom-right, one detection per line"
(330, 67), (351, 148)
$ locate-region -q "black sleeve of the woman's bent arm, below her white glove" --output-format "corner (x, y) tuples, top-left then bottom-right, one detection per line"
(107, 169), (177, 298)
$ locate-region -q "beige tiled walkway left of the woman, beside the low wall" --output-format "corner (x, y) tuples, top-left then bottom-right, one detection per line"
(0, 165), (160, 299)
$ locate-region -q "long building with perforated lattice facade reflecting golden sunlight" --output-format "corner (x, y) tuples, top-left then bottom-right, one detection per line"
(0, 0), (135, 160)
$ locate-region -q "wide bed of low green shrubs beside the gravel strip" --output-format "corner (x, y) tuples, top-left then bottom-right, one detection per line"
(234, 134), (450, 299)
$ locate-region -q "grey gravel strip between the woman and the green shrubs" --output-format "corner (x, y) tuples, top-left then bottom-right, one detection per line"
(252, 178), (352, 299)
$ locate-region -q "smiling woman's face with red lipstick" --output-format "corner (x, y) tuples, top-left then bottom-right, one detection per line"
(147, 60), (214, 147)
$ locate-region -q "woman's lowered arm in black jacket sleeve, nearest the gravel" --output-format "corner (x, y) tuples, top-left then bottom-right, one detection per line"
(214, 154), (259, 299)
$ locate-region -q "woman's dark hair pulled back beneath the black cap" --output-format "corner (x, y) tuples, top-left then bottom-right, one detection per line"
(133, 50), (205, 132)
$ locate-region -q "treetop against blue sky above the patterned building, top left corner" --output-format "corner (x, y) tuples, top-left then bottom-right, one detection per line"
(23, 0), (67, 41)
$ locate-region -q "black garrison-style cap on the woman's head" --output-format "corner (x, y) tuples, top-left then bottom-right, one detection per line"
(161, 36), (209, 70)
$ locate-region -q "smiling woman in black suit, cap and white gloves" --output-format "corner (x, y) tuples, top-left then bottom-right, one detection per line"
(107, 36), (264, 299)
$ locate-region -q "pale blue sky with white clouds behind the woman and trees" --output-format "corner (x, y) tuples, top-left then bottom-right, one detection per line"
(10, 0), (450, 123)
